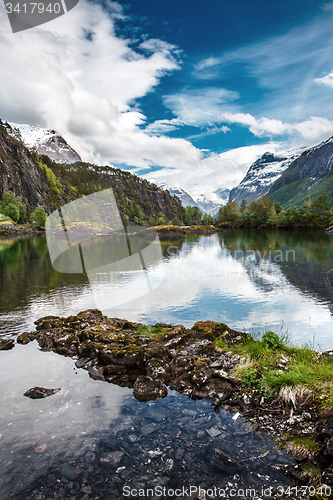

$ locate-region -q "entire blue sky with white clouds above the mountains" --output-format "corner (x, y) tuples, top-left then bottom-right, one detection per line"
(0, 0), (333, 199)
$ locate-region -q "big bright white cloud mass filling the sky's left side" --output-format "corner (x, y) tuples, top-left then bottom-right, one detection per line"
(0, 0), (202, 168)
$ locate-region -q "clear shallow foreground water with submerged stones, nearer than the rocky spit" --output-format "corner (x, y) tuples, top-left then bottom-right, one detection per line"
(0, 343), (293, 500)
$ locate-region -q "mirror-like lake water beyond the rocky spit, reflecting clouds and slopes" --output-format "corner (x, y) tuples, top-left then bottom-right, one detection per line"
(0, 230), (333, 349)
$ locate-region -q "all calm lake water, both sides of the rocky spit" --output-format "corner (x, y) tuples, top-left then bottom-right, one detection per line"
(0, 230), (333, 500)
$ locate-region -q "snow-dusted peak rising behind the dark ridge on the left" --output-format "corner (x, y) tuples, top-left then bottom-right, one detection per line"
(8, 122), (82, 163)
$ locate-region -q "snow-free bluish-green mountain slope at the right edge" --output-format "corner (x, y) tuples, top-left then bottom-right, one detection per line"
(268, 137), (333, 208)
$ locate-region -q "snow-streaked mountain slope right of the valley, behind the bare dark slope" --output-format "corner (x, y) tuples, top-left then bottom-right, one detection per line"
(229, 148), (304, 204)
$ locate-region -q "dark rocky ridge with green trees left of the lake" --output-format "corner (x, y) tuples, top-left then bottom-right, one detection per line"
(0, 120), (184, 224)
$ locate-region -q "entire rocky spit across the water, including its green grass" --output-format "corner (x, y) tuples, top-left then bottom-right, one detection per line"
(12, 309), (333, 486)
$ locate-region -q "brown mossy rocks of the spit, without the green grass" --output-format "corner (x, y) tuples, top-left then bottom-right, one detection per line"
(13, 310), (333, 486)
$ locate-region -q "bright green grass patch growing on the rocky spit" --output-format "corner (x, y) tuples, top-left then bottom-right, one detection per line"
(215, 332), (333, 410)
